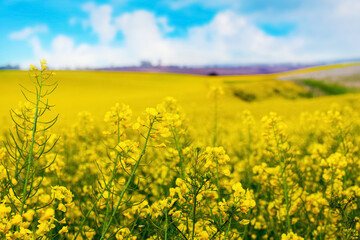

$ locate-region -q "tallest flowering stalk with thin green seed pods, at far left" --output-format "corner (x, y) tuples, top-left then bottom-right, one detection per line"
(5, 60), (58, 215)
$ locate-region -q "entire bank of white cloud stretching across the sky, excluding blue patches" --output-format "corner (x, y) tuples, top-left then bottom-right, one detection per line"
(16, 0), (360, 68)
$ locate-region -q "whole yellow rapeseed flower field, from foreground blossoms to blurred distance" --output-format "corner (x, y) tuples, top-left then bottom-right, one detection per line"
(0, 60), (360, 240)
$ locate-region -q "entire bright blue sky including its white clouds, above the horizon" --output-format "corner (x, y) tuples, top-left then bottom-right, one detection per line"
(0, 0), (360, 68)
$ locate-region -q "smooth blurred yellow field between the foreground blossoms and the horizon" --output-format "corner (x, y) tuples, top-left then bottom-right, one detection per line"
(0, 63), (359, 127)
